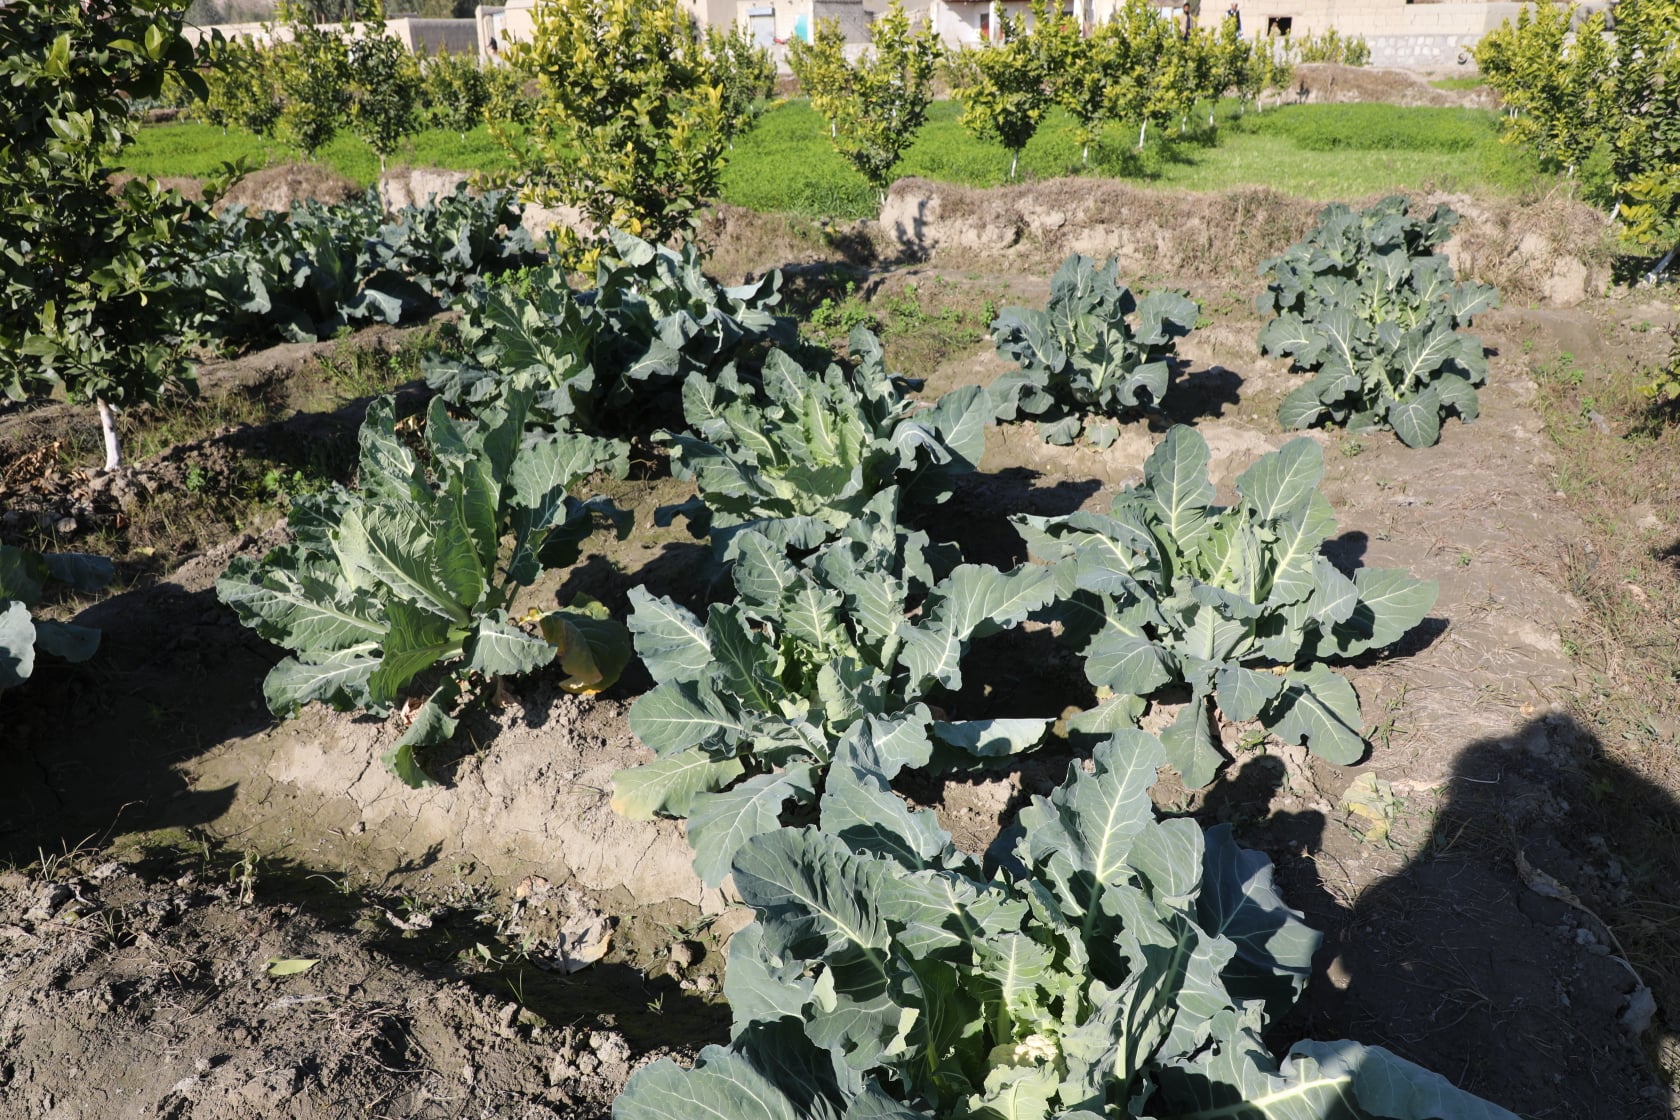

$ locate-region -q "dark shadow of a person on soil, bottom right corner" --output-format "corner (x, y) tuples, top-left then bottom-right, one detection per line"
(1208, 715), (1680, 1120)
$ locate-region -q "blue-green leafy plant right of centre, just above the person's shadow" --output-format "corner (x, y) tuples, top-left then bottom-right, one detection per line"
(1016, 427), (1436, 788)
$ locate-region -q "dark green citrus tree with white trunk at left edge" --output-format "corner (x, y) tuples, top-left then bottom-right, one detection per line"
(0, 0), (216, 470)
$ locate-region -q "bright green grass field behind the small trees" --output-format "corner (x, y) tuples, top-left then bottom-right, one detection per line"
(128, 101), (1544, 218)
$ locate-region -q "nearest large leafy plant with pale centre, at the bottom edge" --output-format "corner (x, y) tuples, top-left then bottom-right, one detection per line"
(613, 720), (1510, 1120)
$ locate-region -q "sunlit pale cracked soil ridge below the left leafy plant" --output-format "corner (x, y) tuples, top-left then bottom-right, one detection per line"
(192, 682), (726, 913)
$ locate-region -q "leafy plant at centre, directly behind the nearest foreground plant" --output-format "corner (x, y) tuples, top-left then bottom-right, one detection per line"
(613, 490), (1053, 883)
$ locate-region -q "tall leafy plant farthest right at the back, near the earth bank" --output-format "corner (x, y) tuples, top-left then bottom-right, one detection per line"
(1258, 195), (1499, 447)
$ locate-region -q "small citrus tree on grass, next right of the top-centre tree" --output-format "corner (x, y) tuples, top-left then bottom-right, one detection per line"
(951, 0), (1063, 180)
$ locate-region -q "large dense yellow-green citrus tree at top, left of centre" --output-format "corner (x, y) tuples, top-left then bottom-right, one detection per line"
(502, 0), (727, 242)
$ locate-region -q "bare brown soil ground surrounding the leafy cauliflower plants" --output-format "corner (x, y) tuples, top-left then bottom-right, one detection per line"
(0, 181), (1680, 1120)
